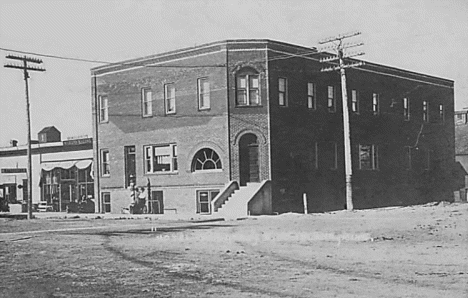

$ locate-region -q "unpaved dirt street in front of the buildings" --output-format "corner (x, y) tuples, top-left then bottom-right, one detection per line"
(0, 202), (468, 297)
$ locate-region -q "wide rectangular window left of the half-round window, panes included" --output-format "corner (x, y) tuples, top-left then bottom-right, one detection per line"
(144, 144), (178, 174)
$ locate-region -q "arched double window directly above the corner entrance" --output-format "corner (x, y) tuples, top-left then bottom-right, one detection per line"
(236, 70), (260, 106)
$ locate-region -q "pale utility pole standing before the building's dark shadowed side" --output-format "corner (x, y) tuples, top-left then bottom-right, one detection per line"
(319, 32), (364, 211)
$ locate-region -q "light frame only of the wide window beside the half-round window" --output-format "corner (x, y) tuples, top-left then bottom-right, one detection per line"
(143, 143), (179, 175)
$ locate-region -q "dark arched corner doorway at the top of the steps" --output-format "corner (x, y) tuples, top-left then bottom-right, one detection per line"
(239, 133), (260, 186)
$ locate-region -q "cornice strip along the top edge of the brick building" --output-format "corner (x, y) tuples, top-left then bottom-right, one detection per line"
(91, 39), (454, 87)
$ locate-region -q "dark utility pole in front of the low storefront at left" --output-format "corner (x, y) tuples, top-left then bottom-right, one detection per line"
(4, 55), (45, 219)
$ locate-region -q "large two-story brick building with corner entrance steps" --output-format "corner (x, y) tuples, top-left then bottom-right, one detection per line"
(92, 40), (455, 214)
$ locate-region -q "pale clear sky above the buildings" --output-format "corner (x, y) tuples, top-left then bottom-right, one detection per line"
(0, 0), (468, 147)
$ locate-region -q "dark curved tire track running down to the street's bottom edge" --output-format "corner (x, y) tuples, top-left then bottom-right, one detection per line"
(99, 232), (310, 298)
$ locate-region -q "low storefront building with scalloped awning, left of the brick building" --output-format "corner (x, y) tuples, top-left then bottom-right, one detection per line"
(0, 126), (94, 211)
